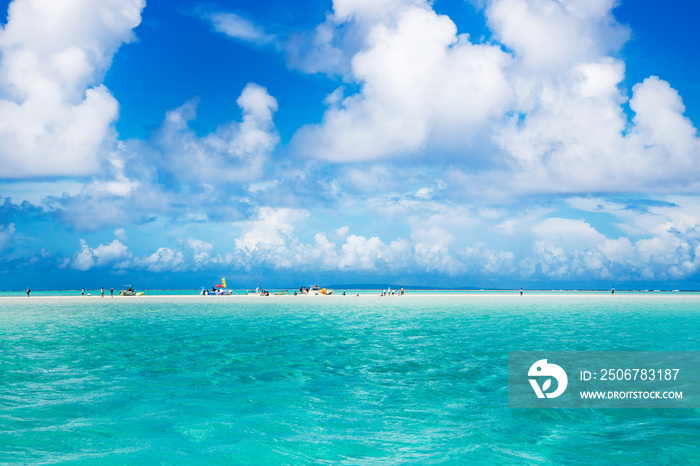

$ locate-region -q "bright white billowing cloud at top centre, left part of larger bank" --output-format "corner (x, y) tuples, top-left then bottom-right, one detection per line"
(296, 0), (510, 162)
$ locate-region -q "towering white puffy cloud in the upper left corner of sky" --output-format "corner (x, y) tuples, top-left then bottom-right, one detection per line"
(0, 0), (145, 178)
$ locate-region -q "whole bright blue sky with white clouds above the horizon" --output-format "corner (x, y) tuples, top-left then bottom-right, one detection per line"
(0, 0), (700, 289)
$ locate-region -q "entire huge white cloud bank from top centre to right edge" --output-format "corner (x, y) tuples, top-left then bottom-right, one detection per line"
(294, 0), (700, 196)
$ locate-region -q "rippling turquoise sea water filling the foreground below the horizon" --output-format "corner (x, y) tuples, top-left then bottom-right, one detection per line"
(0, 291), (700, 465)
